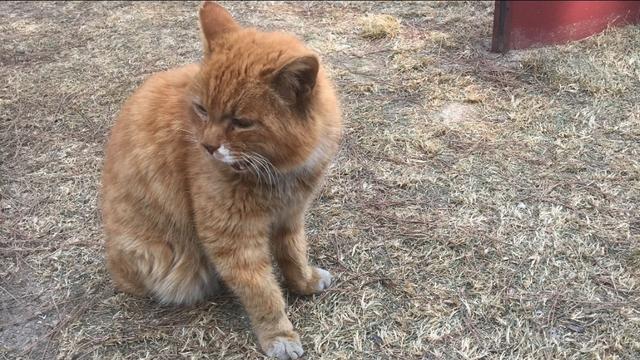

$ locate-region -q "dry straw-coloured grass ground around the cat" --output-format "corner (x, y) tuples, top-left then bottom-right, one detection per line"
(0, 2), (640, 359)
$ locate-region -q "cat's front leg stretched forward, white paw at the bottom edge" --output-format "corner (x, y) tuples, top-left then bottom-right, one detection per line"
(198, 224), (304, 359)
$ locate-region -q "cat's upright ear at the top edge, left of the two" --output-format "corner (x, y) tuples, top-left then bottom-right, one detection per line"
(200, 1), (240, 56)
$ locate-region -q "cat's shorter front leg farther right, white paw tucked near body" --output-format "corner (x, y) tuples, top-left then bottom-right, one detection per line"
(271, 209), (332, 295)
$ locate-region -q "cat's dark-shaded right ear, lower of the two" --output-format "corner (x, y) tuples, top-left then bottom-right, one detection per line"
(272, 55), (320, 110)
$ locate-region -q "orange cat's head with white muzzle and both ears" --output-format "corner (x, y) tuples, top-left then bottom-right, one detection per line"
(189, 2), (340, 176)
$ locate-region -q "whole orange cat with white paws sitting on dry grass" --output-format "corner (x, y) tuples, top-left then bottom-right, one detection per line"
(102, 2), (341, 359)
